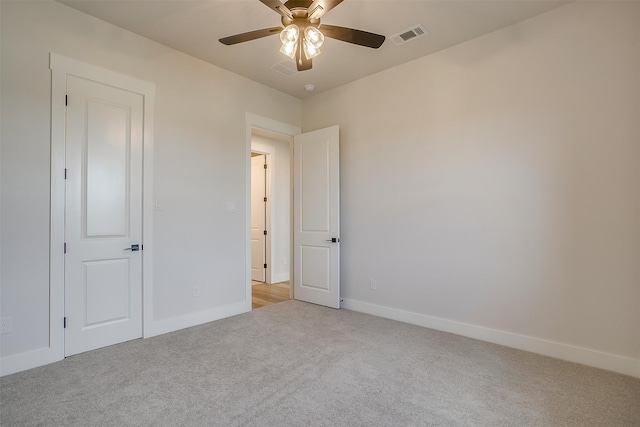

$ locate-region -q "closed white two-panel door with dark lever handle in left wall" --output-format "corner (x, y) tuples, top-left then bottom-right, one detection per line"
(65, 76), (143, 356)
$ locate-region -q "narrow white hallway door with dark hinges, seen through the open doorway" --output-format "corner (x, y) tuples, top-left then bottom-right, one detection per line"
(251, 154), (267, 282)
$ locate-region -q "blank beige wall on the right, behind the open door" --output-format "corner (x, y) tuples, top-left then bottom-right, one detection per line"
(303, 2), (640, 368)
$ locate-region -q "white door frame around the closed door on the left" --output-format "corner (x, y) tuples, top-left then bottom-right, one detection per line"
(49, 52), (155, 361)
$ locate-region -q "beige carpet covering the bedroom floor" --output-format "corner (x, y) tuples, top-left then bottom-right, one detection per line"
(0, 301), (640, 427)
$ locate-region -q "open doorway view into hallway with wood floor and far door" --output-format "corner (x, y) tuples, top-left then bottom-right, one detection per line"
(250, 127), (292, 309)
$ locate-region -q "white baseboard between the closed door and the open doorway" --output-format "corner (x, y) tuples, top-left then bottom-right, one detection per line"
(144, 302), (251, 338)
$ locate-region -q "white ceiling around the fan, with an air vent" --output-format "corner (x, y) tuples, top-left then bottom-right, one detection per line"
(60, 0), (568, 98)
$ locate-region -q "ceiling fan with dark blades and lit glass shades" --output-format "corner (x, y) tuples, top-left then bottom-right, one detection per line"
(220, 0), (385, 71)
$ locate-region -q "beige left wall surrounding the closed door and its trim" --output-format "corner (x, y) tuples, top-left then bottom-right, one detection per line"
(0, 1), (301, 357)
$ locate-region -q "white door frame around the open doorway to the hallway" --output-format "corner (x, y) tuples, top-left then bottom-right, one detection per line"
(244, 112), (302, 302)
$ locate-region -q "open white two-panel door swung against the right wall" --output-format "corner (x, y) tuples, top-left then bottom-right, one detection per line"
(293, 126), (340, 308)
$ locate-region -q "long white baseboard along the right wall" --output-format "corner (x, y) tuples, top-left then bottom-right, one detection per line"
(342, 299), (640, 378)
